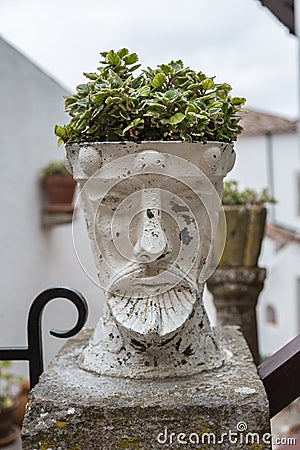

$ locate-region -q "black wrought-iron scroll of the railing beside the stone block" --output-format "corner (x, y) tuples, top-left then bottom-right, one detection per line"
(0, 286), (88, 388)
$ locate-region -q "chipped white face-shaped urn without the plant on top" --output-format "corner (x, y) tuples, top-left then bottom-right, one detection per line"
(66, 141), (235, 378)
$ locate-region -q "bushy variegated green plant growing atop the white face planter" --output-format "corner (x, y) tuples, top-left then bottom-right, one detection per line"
(55, 48), (245, 145)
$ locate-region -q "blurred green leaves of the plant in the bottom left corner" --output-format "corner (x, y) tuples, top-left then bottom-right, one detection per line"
(0, 361), (23, 409)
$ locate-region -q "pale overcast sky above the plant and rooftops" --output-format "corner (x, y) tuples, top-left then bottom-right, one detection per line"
(0, 0), (298, 118)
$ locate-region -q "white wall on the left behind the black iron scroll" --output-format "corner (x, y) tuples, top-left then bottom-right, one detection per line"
(0, 39), (102, 376)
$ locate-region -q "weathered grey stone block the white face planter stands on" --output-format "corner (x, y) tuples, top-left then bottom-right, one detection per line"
(23, 327), (271, 450)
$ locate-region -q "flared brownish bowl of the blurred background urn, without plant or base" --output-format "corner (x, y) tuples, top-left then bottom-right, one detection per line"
(217, 205), (266, 267)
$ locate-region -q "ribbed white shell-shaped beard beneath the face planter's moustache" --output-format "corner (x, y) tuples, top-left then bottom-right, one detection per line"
(108, 287), (197, 337)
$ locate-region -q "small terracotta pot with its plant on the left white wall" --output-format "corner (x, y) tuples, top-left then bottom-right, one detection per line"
(42, 161), (76, 213)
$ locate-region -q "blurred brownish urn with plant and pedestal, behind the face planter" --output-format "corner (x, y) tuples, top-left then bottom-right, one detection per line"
(207, 181), (275, 364)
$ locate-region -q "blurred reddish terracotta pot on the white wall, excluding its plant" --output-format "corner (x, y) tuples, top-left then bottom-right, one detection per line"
(42, 175), (76, 212)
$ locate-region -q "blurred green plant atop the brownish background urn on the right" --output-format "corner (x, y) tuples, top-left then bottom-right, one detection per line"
(222, 180), (276, 205)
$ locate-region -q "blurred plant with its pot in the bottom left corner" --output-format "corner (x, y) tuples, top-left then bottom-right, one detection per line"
(0, 361), (25, 446)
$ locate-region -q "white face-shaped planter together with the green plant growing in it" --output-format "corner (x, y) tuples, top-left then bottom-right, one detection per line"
(55, 48), (245, 378)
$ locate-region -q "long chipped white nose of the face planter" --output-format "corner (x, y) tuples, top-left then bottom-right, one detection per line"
(134, 190), (167, 263)
